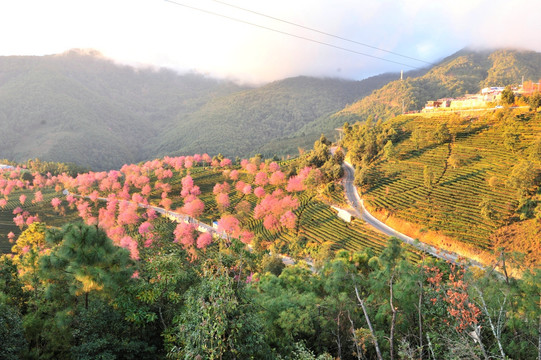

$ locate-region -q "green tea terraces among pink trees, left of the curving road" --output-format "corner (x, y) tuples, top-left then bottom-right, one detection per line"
(0, 158), (426, 261)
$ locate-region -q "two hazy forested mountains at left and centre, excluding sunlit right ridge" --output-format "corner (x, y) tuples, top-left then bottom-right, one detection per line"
(0, 50), (390, 170)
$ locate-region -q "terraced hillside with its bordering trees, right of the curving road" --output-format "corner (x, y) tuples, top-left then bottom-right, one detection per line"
(344, 109), (541, 266)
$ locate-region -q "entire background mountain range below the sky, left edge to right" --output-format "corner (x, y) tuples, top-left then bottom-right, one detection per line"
(0, 49), (541, 170)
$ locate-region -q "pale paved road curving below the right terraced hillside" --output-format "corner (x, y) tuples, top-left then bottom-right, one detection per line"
(342, 161), (482, 267)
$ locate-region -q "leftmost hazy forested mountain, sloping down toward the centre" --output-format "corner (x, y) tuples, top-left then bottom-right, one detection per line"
(0, 51), (242, 172)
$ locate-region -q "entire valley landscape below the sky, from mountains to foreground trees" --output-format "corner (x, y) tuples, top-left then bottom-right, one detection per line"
(0, 50), (541, 360)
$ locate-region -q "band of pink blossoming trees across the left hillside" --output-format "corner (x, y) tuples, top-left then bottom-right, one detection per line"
(0, 154), (319, 259)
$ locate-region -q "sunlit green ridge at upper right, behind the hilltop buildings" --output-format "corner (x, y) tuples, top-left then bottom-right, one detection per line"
(334, 49), (541, 123)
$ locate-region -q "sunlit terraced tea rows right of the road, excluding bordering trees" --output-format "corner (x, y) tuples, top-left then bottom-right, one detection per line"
(356, 112), (541, 262)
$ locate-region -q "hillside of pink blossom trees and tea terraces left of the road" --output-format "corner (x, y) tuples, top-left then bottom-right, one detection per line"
(0, 138), (426, 261)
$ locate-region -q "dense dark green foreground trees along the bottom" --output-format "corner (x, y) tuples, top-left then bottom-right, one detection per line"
(0, 224), (541, 359)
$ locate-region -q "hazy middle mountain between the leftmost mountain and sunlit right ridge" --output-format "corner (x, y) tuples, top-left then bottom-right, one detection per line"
(153, 75), (396, 156)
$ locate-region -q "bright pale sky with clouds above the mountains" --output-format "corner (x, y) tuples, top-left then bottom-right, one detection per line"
(0, 0), (541, 84)
